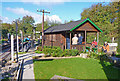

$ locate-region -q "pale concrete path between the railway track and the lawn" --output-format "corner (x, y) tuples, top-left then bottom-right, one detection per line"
(19, 53), (44, 81)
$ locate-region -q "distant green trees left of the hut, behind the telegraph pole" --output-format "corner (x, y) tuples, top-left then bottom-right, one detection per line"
(0, 15), (60, 38)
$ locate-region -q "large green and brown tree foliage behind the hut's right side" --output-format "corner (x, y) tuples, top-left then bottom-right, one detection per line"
(81, 2), (120, 44)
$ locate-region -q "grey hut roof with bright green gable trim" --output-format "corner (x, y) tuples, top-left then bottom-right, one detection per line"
(44, 18), (102, 33)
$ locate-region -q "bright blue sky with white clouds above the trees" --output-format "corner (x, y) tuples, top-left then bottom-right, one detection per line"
(0, 0), (112, 24)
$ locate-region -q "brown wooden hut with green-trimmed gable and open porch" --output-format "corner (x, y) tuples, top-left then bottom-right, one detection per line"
(44, 18), (102, 51)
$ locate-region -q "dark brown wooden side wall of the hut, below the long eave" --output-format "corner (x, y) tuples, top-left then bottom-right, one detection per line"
(44, 33), (65, 49)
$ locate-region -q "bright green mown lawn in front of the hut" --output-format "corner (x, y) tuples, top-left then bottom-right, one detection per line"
(34, 58), (120, 79)
